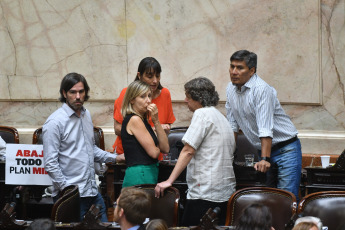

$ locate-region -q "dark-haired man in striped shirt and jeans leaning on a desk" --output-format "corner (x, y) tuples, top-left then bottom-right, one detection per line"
(225, 50), (302, 199)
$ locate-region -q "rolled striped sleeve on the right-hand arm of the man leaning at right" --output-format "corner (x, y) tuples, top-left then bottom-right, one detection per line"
(255, 87), (277, 138)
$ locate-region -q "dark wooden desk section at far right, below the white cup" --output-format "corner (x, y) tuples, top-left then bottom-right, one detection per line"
(304, 167), (345, 195)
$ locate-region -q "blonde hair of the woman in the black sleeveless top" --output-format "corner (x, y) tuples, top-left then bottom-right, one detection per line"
(121, 80), (151, 119)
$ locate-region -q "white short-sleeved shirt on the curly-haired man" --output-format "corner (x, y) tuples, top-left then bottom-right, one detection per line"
(182, 106), (236, 202)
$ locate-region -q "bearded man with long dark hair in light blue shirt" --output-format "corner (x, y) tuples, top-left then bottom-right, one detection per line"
(43, 73), (123, 222)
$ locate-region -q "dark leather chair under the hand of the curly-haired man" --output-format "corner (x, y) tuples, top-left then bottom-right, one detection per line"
(135, 184), (180, 227)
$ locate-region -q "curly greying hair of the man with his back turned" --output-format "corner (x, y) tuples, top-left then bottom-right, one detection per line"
(184, 77), (219, 107)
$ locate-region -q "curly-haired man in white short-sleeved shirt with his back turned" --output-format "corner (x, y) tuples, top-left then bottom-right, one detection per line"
(155, 77), (236, 226)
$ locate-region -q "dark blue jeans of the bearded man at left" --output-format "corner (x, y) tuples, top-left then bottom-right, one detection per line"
(80, 193), (108, 222)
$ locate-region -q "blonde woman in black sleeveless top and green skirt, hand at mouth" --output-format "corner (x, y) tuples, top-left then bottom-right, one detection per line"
(121, 81), (169, 187)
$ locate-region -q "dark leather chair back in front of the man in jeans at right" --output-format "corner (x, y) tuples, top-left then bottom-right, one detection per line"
(225, 187), (297, 230)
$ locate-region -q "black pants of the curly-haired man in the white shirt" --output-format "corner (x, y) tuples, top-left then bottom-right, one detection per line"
(181, 200), (228, 226)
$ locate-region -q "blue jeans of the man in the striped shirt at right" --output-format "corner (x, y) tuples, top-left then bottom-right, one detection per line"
(266, 139), (302, 201)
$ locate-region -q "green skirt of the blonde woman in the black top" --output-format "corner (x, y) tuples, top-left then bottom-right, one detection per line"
(122, 163), (158, 188)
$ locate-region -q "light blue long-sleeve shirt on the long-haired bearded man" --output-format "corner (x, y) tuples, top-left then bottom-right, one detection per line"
(43, 103), (116, 197)
